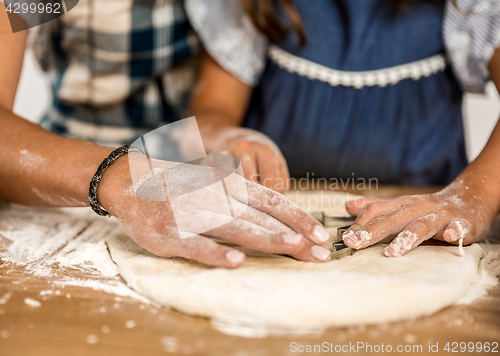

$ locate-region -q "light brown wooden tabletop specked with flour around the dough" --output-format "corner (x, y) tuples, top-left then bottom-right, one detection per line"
(0, 187), (500, 356)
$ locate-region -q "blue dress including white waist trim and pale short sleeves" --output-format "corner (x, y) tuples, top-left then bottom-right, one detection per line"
(185, 0), (500, 184)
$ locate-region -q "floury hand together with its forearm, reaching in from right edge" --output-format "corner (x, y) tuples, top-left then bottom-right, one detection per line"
(343, 49), (500, 256)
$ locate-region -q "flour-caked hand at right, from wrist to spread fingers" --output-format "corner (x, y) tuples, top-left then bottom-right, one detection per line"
(343, 180), (498, 257)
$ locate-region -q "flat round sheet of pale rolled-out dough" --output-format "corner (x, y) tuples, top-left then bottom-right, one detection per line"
(108, 235), (482, 329)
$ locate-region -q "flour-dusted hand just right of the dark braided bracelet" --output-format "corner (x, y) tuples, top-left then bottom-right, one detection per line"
(98, 153), (330, 268)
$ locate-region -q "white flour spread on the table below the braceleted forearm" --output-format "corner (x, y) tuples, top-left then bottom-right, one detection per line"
(0, 204), (148, 304)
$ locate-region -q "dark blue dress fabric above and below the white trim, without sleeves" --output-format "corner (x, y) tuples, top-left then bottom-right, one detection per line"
(245, 0), (467, 184)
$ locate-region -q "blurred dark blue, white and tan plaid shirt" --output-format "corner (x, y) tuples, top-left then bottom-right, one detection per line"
(27, 0), (199, 145)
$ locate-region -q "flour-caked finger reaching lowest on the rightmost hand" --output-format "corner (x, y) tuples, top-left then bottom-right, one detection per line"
(384, 213), (445, 257)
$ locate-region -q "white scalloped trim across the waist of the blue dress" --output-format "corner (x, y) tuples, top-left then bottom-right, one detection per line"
(268, 45), (446, 89)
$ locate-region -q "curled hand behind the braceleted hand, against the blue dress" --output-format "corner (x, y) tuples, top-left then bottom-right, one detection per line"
(203, 126), (290, 194)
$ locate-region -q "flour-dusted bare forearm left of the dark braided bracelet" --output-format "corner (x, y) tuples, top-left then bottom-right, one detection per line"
(0, 107), (113, 206)
